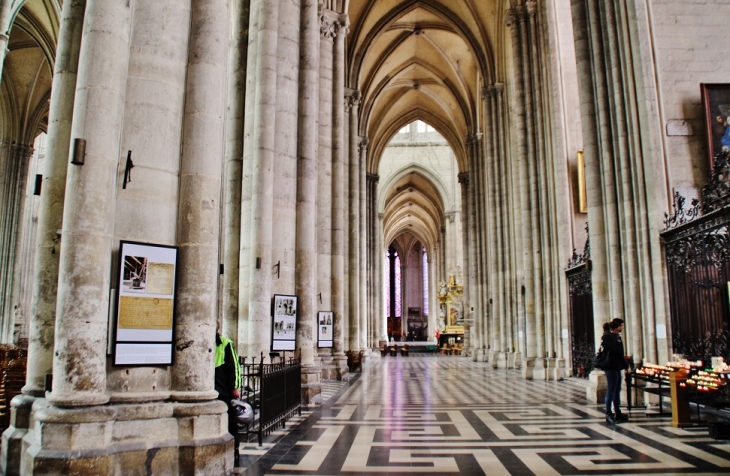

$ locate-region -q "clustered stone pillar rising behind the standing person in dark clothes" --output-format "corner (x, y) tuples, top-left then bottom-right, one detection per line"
(571, 0), (668, 400)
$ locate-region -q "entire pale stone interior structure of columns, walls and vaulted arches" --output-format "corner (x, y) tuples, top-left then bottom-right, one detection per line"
(0, 0), (730, 475)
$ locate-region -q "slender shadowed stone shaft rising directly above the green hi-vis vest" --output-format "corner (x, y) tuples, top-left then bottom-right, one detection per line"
(221, 0), (250, 342)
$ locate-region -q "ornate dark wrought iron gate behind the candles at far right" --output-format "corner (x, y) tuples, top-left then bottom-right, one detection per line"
(661, 152), (730, 360)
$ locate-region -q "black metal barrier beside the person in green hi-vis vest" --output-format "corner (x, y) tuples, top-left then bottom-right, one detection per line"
(241, 352), (302, 446)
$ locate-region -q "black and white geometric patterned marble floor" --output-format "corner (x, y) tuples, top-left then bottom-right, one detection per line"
(239, 356), (730, 476)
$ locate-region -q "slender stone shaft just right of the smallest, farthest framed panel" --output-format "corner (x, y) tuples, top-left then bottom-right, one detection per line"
(331, 16), (352, 364)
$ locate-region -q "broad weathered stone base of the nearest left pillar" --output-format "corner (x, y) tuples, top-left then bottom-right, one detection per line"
(19, 399), (233, 476)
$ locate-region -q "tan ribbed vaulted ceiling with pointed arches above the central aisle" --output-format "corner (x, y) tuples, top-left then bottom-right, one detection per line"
(347, 0), (503, 253)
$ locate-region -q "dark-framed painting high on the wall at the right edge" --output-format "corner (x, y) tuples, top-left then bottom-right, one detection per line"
(700, 83), (730, 166)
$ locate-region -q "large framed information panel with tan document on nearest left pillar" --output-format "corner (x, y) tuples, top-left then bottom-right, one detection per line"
(113, 241), (177, 366)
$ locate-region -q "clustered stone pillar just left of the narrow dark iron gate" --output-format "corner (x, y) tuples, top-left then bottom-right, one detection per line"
(504, 1), (560, 379)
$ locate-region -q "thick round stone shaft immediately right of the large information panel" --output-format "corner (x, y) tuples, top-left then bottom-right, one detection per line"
(171, 0), (228, 401)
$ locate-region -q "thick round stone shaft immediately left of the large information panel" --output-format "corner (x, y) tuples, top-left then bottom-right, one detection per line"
(47, 0), (131, 407)
